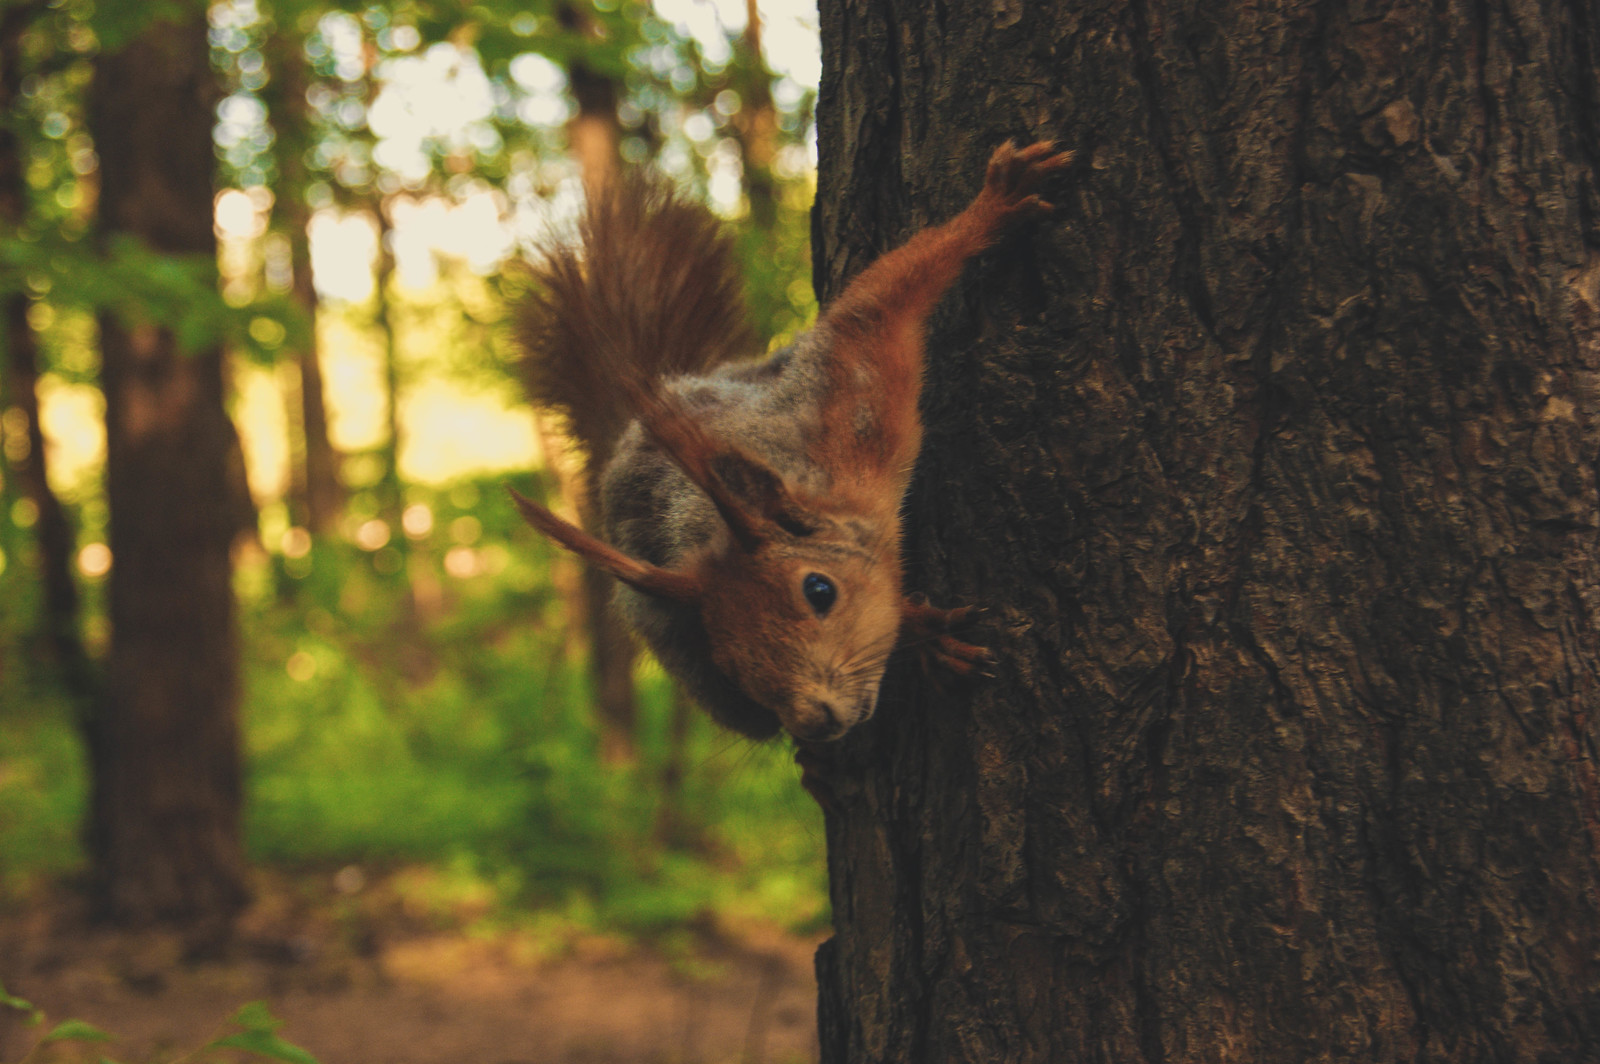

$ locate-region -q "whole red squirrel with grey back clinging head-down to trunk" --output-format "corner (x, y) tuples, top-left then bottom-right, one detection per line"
(512, 142), (1074, 742)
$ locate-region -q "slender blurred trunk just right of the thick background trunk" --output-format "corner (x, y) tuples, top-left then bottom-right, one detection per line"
(269, 29), (344, 533)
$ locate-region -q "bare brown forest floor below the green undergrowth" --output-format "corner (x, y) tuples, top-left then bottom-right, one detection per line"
(0, 867), (822, 1064)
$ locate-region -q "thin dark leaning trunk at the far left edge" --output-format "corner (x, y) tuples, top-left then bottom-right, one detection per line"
(0, 3), (94, 701)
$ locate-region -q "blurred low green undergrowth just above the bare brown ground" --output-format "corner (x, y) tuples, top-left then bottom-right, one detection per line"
(0, 470), (826, 931)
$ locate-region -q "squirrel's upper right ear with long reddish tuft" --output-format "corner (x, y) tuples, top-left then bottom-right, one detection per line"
(632, 389), (816, 550)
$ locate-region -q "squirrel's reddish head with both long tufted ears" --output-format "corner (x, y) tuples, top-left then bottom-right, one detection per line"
(512, 385), (901, 742)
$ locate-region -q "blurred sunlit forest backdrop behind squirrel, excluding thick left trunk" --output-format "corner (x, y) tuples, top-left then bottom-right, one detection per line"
(0, 0), (827, 1056)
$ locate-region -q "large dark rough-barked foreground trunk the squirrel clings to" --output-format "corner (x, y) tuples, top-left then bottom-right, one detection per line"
(816, 0), (1600, 1064)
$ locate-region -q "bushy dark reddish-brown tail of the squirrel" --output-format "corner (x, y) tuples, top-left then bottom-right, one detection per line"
(517, 174), (757, 472)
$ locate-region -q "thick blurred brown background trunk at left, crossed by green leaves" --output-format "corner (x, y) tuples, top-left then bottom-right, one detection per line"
(90, 18), (245, 926)
